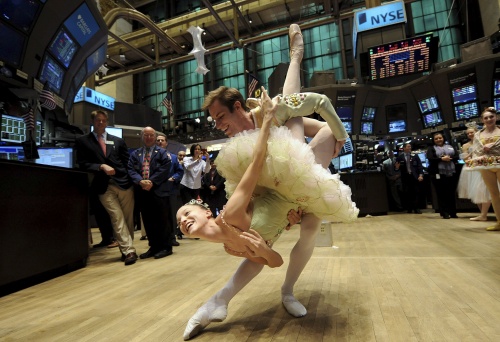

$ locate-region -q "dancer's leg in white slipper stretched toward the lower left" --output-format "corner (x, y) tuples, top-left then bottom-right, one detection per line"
(184, 259), (264, 341)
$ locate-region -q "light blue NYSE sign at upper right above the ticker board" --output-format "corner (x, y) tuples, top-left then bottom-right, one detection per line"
(354, 1), (406, 32)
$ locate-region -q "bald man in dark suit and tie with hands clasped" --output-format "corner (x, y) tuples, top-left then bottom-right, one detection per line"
(128, 127), (173, 259)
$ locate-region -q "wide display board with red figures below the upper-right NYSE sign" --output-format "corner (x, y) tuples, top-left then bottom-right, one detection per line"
(368, 34), (438, 81)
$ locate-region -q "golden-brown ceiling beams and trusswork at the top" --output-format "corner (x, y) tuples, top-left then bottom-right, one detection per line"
(96, 0), (364, 85)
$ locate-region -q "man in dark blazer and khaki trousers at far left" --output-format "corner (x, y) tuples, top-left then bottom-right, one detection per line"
(76, 110), (137, 265)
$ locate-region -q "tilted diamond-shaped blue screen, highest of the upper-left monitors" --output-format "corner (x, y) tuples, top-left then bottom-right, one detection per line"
(64, 3), (100, 46)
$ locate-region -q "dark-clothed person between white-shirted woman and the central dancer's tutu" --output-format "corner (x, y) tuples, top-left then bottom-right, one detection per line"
(201, 160), (227, 217)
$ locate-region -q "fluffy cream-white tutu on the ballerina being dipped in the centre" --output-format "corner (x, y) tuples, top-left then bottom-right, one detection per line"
(216, 127), (359, 222)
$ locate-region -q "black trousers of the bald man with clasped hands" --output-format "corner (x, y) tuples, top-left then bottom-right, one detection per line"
(136, 188), (173, 253)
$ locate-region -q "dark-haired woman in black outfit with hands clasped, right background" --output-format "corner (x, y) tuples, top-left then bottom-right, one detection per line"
(427, 133), (458, 219)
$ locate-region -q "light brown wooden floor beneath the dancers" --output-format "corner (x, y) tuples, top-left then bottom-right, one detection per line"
(0, 212), (500, 342)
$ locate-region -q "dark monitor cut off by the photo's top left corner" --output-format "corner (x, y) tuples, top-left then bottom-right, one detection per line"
(0, 0), (40, 32)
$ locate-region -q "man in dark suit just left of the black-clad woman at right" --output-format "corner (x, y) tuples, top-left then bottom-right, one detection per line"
(396, 143), (424, 214)
